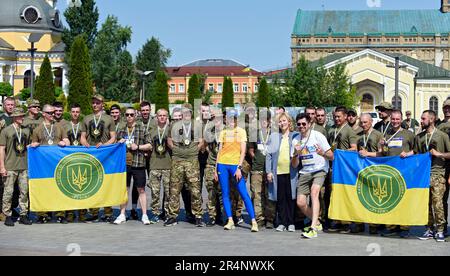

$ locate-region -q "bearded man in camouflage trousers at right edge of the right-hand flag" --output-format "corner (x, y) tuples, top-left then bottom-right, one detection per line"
(414, 110), (450, 242)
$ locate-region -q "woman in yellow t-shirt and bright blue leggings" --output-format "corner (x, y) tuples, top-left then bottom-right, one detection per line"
(216, 109), (258, 232)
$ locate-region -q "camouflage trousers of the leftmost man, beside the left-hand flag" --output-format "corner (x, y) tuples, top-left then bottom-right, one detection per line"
(2, 170), (28, 217)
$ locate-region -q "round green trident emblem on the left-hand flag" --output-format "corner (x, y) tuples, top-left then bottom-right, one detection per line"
(55, 153), (105, 200)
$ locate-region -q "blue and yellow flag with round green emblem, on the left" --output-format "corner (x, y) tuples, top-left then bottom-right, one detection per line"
(28, 144), (128, 212)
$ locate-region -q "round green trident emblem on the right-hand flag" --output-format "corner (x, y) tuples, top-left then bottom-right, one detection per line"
(356, 165), (406, 214)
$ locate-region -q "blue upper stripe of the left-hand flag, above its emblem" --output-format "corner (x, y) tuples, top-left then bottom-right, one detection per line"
(28, 144), (126, 179)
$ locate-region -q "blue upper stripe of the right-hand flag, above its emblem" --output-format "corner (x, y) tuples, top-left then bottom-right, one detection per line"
(332, 150), (431, 189)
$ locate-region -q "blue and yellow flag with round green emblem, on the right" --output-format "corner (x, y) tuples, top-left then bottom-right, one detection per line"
(329, 150), (431, 226)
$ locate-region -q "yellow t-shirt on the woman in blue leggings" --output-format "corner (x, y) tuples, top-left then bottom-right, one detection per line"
(217, 127), (247, 165)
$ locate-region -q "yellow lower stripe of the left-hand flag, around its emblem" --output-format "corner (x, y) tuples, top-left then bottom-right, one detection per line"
(30, 173), (128, 212)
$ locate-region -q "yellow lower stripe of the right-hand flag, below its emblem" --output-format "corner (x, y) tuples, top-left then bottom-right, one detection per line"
(329, 185), (429, 226)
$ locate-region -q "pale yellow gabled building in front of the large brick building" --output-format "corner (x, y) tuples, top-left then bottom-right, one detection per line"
(313, 49), (450, 118)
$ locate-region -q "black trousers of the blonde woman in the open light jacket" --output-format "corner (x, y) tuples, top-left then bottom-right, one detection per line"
(277, 174), (295, 227)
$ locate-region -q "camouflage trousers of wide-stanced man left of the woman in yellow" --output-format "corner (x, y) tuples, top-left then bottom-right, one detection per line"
(168, 159), (203, 219)
